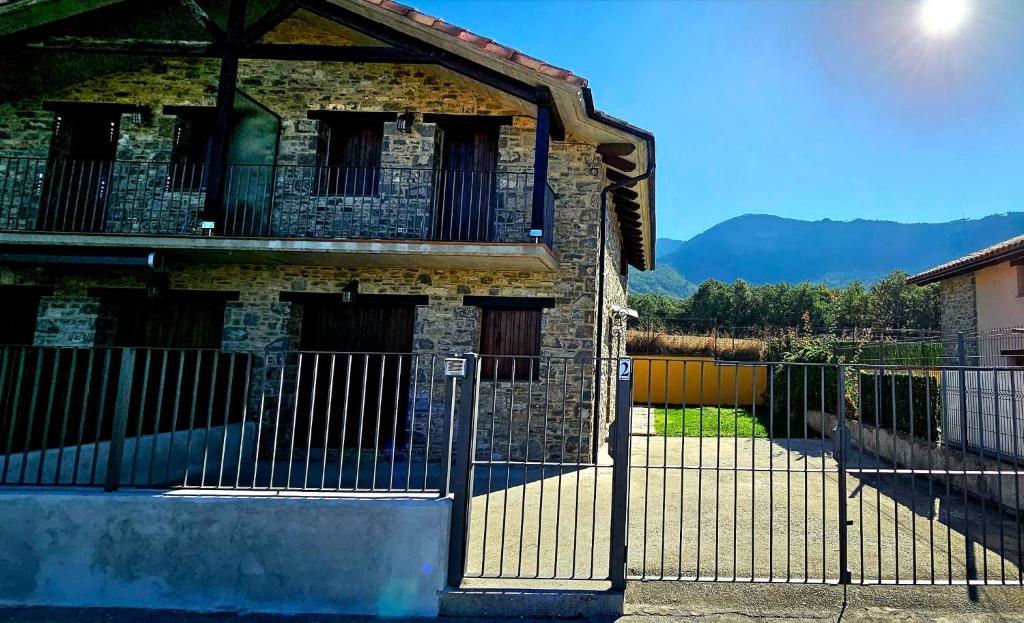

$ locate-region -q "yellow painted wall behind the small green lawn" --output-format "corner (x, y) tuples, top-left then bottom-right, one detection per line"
(633, 357), (768, 406)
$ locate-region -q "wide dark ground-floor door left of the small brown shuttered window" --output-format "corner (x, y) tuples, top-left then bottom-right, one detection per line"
(295, 297), (416, 452)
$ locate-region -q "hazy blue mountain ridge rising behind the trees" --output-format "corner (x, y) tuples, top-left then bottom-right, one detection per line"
(630, 212), (1024, 296)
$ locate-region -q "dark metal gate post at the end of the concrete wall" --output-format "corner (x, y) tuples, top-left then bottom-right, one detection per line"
(442, 352), (478, 588)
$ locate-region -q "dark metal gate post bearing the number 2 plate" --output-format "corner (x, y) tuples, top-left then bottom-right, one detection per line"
(599, 357), (633, 590)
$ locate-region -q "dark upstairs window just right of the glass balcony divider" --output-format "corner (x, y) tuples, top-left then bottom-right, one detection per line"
(312, 113), (384, 197)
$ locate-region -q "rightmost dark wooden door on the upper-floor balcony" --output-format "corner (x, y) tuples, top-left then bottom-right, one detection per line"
(434, 124), (498, 242)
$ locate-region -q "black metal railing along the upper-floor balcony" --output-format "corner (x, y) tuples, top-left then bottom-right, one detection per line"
(0, 157), (554, 246)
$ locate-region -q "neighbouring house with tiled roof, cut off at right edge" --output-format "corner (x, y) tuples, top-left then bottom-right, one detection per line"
(907, 236), (1024, 460)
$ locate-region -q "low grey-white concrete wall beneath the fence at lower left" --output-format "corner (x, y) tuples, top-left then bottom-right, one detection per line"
(0, 488), (451, 616)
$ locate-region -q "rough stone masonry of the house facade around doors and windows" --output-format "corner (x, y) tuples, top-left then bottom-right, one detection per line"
(0, 10), (626, 459)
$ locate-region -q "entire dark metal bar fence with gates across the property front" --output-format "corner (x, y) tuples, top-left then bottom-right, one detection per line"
(0, 346), (1024, 586)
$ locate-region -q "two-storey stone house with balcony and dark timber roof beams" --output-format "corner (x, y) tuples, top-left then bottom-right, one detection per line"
(0, 0), (655, 471)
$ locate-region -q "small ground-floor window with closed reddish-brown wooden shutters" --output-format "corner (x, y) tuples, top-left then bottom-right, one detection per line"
(480, 307), (541, 380)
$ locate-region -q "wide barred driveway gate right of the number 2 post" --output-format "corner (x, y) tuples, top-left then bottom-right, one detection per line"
(627, 359), (1024, 585)
